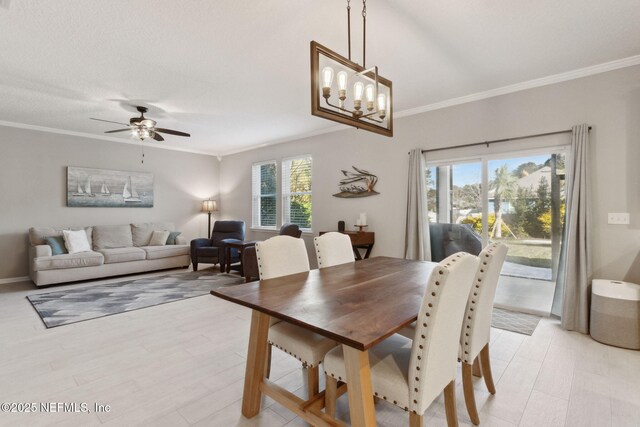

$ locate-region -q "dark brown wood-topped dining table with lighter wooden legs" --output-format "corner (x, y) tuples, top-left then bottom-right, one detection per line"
(211, 257), (438, 426)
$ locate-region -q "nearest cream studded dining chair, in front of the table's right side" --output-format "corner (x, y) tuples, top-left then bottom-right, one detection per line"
(324, 252), (479, 426)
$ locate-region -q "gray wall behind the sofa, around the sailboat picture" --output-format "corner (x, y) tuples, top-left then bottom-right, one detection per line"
(0, 127), (219, 280)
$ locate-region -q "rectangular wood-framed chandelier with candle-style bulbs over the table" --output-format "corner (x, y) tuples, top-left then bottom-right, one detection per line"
(311, 0), (393, 136)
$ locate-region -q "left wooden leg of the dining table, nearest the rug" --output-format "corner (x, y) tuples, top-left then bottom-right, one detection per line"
(242, 310), (271, 418)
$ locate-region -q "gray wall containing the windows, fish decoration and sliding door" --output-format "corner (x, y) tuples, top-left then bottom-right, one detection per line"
(220, 66), (640, 282)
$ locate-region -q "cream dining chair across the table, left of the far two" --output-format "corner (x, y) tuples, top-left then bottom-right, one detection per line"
(255, 236), (337, 398)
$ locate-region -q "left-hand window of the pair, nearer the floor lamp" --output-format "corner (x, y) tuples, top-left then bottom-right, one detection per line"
(252, 161), (277, 229)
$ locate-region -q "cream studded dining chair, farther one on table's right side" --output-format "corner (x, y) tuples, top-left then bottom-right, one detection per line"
(400, 243), (508, 425)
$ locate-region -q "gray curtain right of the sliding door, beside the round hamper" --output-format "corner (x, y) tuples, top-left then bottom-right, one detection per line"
(551, 124), (592, 334)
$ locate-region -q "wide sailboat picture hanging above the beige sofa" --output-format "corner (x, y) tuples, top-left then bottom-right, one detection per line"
(67, 166), (153, 208)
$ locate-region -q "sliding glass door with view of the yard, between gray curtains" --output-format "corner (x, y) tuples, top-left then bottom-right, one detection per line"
(427, 147), (565, 314)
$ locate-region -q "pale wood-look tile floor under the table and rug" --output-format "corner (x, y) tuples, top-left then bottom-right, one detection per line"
(0, 272), (640, 427)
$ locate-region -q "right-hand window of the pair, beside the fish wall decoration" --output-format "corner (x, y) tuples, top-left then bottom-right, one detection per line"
(282, 156), (312, 231)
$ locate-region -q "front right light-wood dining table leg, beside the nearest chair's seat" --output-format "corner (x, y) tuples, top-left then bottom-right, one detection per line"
(342, 345), (376, 427)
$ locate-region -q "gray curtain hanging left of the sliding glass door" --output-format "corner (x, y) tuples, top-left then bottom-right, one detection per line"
(404, 148), (431, 261)
